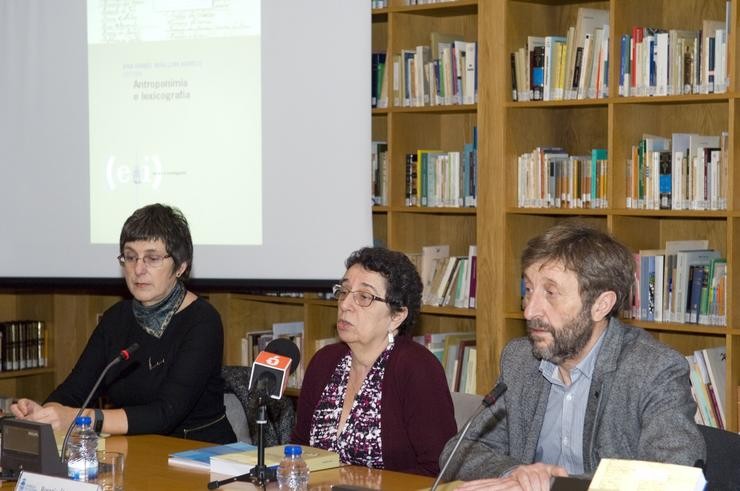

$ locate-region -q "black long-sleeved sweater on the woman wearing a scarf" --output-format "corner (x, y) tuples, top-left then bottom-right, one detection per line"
(47, 299), (236, 443)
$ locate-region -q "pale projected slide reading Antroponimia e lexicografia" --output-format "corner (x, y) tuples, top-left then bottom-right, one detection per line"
(88, 0), (263, 245)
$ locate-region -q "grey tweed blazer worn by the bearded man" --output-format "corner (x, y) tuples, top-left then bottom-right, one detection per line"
(440, 319), (705, 480)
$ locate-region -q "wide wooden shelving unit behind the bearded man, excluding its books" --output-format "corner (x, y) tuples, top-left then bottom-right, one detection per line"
(486, 0), (740, 431)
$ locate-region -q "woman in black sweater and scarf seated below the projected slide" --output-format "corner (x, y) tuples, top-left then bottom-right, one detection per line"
(11, 204), (236, 443)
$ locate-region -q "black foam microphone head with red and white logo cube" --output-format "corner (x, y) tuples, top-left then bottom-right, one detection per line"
(249, 338), (301, 399)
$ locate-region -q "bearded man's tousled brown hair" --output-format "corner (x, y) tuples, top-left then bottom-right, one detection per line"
(521, 220), (635, 317)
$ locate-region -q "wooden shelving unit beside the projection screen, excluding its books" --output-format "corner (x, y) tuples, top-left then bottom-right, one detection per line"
(372, 0), (480, 384)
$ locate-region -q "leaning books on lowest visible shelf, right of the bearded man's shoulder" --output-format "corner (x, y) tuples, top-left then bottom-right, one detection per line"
(686, 346), (727, 429)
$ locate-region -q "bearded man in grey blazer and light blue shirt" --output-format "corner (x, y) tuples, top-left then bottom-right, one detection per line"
(440, 221), (705, 490)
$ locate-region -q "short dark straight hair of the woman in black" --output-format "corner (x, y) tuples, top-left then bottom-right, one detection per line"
(119, 203), (193, 280)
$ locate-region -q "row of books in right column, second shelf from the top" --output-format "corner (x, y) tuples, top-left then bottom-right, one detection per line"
(625, 132), (729, 210)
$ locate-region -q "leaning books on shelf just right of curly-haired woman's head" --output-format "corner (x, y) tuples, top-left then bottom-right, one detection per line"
(406, 245), (478, 309)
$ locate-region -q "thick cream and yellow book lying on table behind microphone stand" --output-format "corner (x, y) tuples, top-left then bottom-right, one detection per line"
(210, 445), (340, 476)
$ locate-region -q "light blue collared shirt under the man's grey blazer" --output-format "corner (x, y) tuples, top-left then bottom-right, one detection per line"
(535, 331), (606, 475)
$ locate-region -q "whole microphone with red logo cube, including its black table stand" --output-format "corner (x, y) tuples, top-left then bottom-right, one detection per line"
(208, 338), (301, 489)
